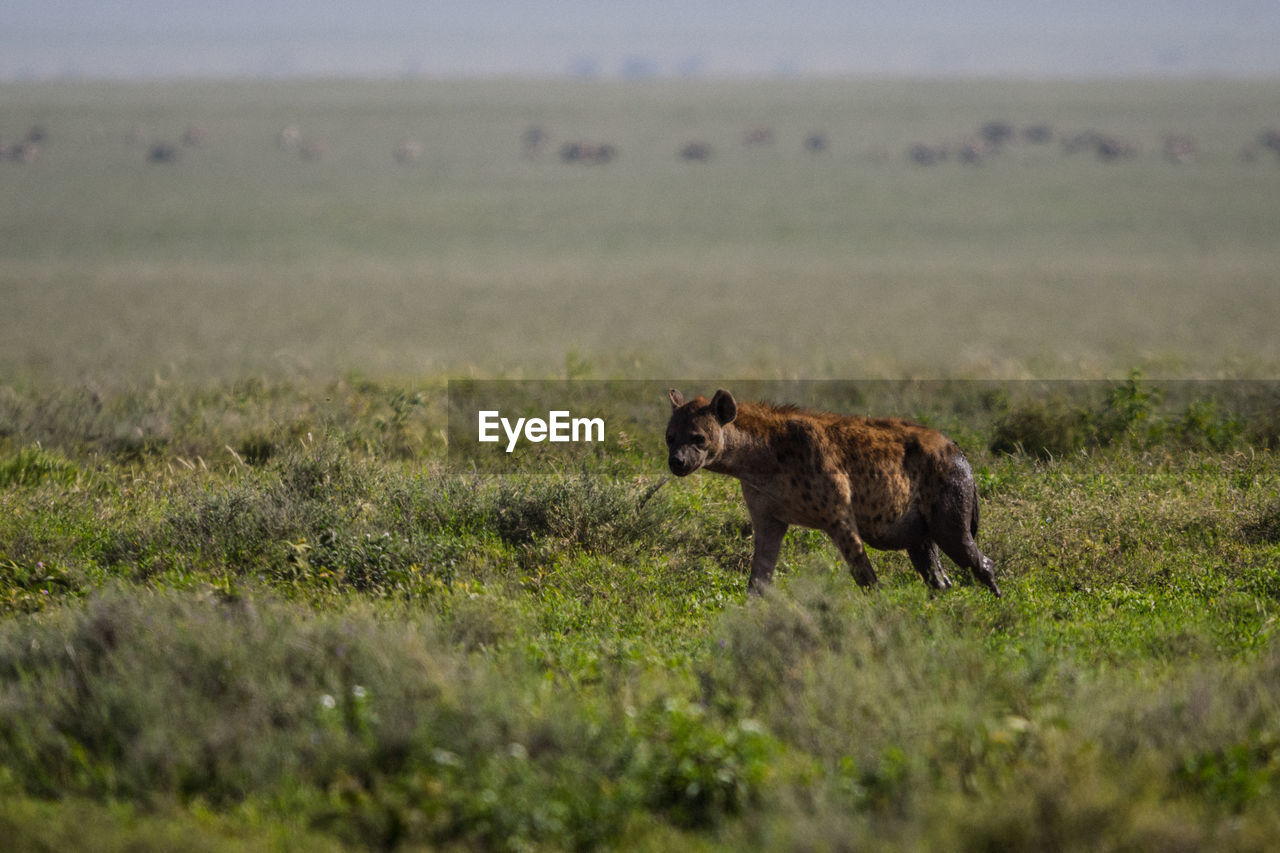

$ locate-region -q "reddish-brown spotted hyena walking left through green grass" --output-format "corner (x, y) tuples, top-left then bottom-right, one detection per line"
(667, 388), (1000, 596)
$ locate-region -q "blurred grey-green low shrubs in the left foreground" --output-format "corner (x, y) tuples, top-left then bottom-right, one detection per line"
(0, 587), (777, 849)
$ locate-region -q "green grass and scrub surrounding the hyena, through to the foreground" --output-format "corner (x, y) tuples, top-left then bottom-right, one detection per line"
(0, 377), (1280, 849)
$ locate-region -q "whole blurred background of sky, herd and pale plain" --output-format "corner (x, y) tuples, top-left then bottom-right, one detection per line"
(0, 0), (1280, 382)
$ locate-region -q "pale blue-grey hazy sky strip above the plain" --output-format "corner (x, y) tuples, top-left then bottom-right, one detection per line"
(0, 0), (1280, 79)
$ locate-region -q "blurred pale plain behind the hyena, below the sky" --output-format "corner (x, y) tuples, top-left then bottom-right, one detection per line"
(0, 81), (1280, 380)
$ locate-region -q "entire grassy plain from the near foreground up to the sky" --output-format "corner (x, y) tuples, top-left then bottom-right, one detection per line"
(0, 81), (1280, 850)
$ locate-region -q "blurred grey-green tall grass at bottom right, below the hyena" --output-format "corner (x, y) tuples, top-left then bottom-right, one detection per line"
(704, 573), (1280, 850)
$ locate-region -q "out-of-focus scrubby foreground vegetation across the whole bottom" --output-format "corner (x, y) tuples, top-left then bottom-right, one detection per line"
(0, 560), (1280, 849)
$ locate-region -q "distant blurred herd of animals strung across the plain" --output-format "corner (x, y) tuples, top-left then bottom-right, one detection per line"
(0, 120), (1280, 167)
